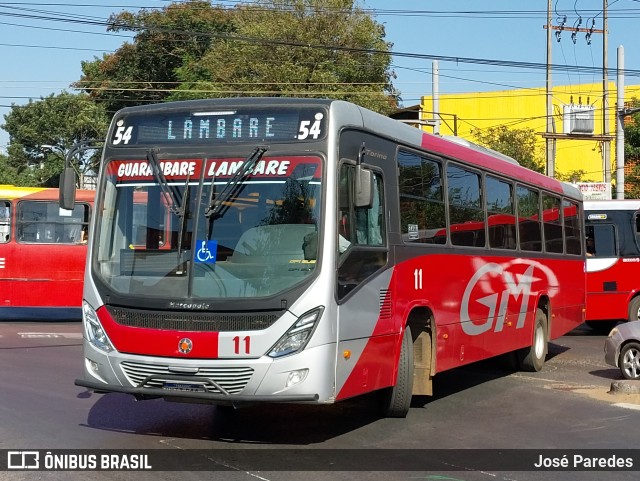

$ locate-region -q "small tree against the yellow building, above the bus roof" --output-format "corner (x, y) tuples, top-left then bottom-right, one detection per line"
(471, 125), (545, 173)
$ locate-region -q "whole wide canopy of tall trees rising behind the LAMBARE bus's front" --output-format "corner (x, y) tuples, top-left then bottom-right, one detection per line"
(75, 0), (399, 113)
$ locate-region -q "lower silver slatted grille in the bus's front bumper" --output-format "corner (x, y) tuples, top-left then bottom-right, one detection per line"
(120, 361), (253, 394)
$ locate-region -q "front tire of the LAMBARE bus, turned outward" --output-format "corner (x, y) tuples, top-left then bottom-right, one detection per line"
(379, 326), (413, 418)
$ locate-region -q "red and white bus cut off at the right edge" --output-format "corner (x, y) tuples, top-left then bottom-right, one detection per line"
(584, 200), (640, 333)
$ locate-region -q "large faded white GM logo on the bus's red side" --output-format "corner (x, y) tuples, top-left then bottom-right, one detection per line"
(460, 260), (558, 336)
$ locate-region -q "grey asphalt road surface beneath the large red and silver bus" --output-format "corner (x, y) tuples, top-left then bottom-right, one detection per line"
(0, 322), (640, 481)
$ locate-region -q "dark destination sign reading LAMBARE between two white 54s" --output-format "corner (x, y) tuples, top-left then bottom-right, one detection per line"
(110, 108), (326, 147)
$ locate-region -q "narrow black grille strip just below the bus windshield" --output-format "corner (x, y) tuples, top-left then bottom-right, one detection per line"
(107, 306), (278, 332)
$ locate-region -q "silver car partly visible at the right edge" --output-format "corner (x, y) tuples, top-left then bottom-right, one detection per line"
(604, 320), (640, 379)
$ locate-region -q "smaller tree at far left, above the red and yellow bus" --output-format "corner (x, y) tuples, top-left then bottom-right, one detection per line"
(2, 92), (108, 187)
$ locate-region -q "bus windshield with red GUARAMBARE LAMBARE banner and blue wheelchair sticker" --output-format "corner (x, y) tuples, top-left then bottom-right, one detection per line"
(94, 151), (322, 300)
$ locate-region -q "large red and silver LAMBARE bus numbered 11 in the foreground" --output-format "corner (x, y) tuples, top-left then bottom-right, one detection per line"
(69, 98), (585, 417)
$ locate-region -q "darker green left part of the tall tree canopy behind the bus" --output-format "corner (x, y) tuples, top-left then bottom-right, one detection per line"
(74, 0), (233, 114)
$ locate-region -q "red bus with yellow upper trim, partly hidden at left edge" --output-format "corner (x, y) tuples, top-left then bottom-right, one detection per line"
(0, 185), (95, 320)
